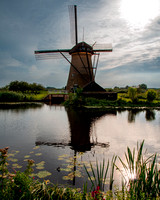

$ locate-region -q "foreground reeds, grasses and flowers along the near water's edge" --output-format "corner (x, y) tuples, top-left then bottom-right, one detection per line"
(0, 141), (160, 200)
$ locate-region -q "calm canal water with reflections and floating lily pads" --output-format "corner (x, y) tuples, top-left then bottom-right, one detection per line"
(0, 103), (160, 187)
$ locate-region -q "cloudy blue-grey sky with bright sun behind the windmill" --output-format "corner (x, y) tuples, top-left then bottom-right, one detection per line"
(0, 0), (160, 88)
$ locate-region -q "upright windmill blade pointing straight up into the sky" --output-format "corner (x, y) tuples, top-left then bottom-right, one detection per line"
(68, 5), (78, 45)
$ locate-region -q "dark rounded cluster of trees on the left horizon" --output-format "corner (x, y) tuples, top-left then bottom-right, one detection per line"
(5, 81), (45, 94)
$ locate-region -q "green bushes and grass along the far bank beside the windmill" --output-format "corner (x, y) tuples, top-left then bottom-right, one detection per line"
(0, 81), (160, 109)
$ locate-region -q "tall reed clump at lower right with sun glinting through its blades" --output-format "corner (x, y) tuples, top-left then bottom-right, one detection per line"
(116, 141), (160, 199)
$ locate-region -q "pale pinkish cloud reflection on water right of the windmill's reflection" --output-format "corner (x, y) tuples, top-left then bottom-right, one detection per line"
(91, 111), (160, 157)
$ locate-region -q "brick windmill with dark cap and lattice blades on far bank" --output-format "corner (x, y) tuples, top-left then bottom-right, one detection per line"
(35, 5), (112, 92)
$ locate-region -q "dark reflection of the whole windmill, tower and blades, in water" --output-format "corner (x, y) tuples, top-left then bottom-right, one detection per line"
(36, 109), (117, 185)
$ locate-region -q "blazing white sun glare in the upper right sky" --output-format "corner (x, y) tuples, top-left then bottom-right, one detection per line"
(120, 0), (160, 29)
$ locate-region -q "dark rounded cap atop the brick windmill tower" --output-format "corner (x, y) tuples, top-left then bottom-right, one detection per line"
(69, 42), (93, 54)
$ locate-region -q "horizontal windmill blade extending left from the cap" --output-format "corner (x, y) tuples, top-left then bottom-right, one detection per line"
(34, 49), (70, 60)
